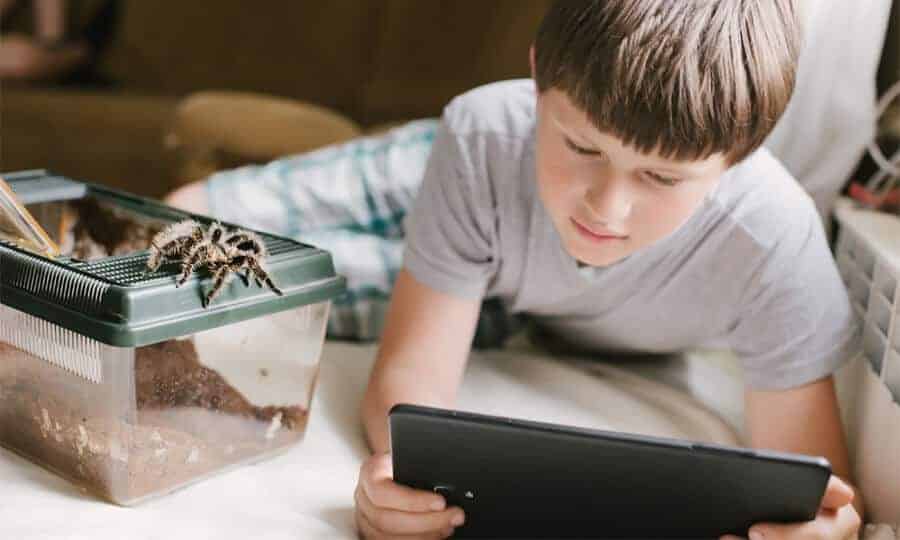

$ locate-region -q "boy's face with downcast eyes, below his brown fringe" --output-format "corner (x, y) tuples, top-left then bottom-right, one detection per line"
(536, 89), (728, 266)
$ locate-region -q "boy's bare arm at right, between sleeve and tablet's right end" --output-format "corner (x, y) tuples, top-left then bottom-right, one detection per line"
(745, 377), (863, 517)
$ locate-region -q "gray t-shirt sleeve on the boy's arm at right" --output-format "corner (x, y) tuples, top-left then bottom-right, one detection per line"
(728, 216), (860, 390)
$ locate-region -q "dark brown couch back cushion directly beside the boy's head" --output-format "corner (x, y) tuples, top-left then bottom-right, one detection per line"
(357, 0), (552, 125)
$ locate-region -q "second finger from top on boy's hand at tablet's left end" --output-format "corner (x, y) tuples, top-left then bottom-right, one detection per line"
(356, 489), (464, 537)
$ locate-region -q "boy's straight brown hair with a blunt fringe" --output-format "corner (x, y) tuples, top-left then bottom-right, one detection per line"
(534, 0), (800, 163)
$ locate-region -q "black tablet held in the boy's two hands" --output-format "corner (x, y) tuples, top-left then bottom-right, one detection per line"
(390, 404), (831, 538)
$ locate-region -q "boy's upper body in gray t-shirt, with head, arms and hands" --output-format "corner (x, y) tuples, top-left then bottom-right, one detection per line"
(172, 0), (861, 540)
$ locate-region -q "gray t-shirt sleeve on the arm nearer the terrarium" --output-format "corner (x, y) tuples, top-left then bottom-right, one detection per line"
(403, 120), (497, 298)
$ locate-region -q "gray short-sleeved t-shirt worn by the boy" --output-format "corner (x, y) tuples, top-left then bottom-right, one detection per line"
(404, 80), (859, 389)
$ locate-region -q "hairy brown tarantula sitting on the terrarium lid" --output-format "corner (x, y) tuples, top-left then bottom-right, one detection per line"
(147, 219), (284, 307)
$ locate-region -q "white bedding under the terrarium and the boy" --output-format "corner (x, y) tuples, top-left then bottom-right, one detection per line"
(0, 343), (894, 540)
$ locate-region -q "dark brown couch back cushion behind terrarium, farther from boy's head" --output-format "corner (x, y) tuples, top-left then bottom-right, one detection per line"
(103, 0), (378, 120)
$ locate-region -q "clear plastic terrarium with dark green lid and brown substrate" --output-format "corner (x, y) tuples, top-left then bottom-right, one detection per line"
(0, 173), (344, 505)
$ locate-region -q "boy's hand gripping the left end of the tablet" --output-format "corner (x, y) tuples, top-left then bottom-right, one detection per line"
(354, 454), (464, 540)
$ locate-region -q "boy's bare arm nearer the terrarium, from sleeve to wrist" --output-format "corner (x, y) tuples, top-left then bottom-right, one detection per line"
(361, 269), (481, 454)
